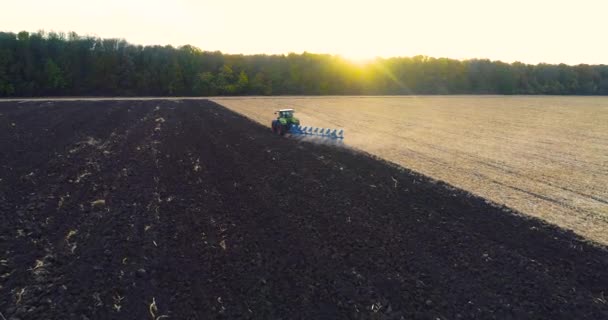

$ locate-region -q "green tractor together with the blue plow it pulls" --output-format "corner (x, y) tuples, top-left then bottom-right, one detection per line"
(272, 109), (344, 141)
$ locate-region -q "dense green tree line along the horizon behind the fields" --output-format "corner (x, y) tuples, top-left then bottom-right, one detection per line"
(0, 31), (608, 97)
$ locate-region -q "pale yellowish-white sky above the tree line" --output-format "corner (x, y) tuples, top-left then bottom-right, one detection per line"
(0, 0), (608, 64)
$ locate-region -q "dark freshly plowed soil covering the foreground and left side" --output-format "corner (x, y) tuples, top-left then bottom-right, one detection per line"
(0, 100), (608, 320)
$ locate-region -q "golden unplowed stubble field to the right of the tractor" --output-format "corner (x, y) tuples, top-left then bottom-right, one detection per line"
(214, 96), (608, 244)
